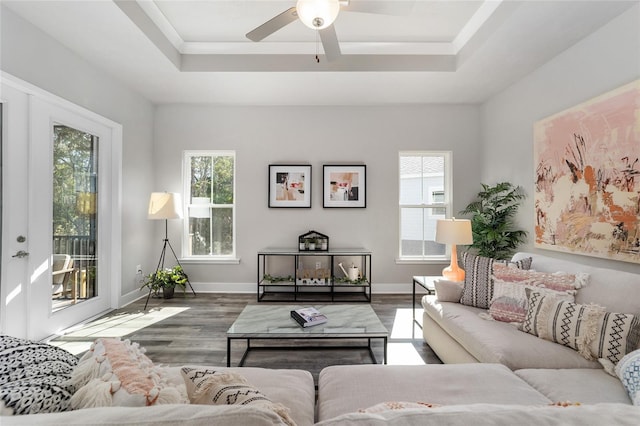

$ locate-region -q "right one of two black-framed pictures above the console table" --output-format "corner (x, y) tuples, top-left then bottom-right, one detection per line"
(322, 164), (367, 208)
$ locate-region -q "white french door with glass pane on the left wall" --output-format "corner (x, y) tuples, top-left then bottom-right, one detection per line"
(0, 75), (121, 340)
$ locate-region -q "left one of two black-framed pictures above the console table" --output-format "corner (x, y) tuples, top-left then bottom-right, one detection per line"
(269, 164), (311, 208)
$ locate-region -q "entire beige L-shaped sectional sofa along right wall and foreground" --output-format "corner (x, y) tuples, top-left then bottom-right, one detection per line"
(0, 253), (640, 426)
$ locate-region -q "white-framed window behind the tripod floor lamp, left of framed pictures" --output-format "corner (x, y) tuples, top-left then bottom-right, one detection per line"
(182, 151), (236, 259)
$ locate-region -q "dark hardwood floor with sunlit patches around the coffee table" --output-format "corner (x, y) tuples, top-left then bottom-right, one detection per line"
(51, 293), (440, 377)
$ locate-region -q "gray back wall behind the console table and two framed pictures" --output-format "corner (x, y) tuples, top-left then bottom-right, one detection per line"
(153, 105), (480, 291)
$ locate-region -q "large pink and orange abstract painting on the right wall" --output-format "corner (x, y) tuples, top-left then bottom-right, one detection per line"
(534, 80), (640, 263)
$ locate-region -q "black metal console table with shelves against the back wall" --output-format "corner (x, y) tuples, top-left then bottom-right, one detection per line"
(256, 248), (371, 302)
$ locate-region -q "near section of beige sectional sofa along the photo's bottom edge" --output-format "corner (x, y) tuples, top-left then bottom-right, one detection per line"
(0, 363), (640, 426)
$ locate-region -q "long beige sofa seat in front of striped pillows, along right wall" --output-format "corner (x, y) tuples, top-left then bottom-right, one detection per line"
(422, 296), (601, 370)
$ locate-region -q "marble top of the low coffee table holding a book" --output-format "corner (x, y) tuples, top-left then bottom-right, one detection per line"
(227, 304), (388, 339)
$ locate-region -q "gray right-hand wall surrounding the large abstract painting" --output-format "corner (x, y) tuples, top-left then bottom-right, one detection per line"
(481, 6), (640, 272)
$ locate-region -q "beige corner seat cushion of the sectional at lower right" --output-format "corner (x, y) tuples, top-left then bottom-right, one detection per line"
(515, 368), (631, 404)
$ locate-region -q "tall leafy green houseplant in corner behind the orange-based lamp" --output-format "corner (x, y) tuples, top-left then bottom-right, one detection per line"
(460, 182), (527, 259)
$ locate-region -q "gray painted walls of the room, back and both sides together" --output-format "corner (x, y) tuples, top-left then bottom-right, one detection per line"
(0, 1), (640, 302)
